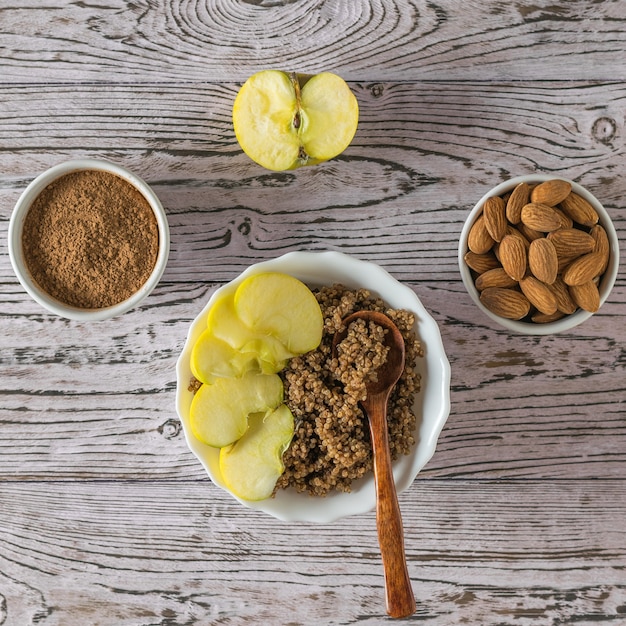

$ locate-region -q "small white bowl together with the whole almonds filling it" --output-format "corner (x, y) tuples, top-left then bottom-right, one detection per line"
(459, 174), (619, 335)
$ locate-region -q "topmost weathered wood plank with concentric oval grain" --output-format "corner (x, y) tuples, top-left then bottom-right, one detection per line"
(0, 0), (626, 84)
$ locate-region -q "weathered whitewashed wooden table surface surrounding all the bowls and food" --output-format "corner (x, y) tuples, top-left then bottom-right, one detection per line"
(0, 0), (626, 626)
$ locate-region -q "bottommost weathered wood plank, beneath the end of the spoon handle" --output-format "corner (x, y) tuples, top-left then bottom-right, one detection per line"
(0, 480), (626, 626)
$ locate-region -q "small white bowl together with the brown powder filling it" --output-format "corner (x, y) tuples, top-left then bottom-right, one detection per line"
(9, 159), (170, 321)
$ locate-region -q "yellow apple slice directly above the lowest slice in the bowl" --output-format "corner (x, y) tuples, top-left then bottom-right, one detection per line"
(189, 373), (283, 448)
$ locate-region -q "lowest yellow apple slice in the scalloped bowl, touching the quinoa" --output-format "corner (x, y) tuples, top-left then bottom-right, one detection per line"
(219, 404), (294, 500)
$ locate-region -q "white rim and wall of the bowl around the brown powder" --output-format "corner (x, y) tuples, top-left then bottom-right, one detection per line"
(9, 159), (170, 321)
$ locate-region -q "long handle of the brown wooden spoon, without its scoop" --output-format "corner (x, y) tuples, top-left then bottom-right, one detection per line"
(367, 394), (416, 617)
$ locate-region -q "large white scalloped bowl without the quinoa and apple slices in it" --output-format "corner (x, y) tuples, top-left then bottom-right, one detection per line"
(176, 252), (450, 523)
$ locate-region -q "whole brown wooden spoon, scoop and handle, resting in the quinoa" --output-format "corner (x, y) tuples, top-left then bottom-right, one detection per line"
(333, 311), (416, 617)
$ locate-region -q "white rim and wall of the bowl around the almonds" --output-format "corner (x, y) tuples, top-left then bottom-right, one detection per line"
(458, 174), (619, 335)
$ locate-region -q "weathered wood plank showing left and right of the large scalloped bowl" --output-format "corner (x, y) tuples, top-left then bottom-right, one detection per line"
(0, 281), (626, 480)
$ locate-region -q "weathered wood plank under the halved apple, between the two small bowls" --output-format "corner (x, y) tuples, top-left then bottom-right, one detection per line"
(0, 83), (626, 288)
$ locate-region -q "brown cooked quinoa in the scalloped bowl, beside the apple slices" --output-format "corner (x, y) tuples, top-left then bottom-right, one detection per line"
(276, 285), (423, 496)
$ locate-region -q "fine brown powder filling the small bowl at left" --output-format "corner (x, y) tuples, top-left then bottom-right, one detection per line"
(22, 170), (159, 309)
